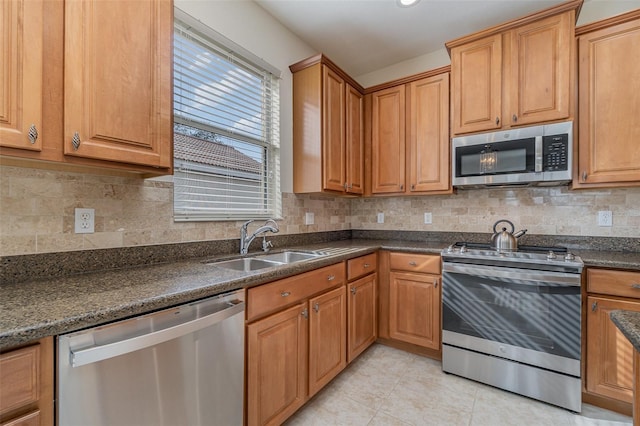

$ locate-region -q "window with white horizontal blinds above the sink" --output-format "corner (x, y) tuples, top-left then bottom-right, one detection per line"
(173, 9), (281, 221)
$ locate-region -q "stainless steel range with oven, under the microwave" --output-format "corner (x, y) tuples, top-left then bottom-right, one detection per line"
(442, 243), (583, 412)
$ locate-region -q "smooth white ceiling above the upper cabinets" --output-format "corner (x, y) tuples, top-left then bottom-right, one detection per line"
(254, 0), (576, 77)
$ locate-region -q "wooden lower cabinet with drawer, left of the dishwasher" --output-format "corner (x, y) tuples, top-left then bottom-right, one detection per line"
(0, 337), (54, 426)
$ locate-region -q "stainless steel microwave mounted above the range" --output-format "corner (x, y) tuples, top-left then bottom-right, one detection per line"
(451, 121), (573, 188)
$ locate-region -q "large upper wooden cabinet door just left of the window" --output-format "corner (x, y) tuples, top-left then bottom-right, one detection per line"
(64, 0), (173, 168)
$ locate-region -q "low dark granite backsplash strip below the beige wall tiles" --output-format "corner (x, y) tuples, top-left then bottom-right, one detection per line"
(0, 230), (640, 283)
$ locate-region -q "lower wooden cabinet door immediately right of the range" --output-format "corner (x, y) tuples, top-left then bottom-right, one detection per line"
(586, 296), (640, 403)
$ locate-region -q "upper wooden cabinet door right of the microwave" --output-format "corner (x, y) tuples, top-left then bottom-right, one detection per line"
(574, 19), (640, 186)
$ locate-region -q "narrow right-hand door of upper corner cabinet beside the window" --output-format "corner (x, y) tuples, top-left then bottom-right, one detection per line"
(345, 84), (364, 194)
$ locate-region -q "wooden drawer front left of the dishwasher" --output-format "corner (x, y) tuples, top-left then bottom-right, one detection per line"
(0, 345), (40, 414)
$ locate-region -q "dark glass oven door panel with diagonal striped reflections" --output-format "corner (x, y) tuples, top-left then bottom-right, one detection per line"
(442, 272), (580, 359)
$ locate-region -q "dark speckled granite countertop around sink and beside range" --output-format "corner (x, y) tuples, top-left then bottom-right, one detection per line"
(0, 239), (640, 349)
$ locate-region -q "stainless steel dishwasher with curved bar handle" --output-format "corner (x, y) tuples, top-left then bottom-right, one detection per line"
(57, 290), (245, 426)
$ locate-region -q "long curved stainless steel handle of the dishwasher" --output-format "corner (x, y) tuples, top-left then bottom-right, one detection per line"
(69, 301), (245, 368)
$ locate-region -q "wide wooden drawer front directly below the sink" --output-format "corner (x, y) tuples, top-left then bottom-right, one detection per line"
(247, 262), (345, 321)
